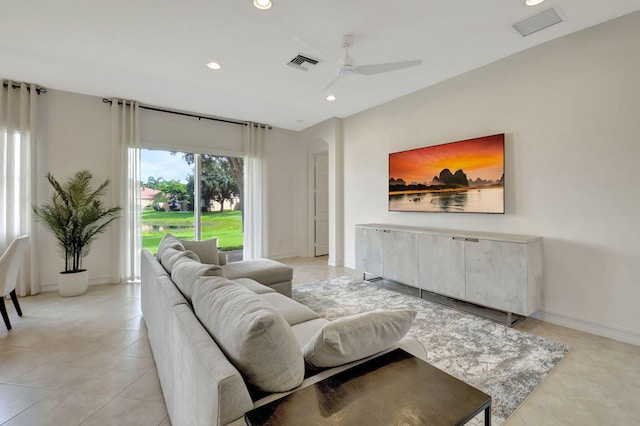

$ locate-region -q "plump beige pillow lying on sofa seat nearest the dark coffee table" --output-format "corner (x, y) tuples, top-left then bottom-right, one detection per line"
(302, 309), (416, 368)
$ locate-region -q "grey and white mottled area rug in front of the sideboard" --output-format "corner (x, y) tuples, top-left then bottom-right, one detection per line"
(293, 277), (570, 425)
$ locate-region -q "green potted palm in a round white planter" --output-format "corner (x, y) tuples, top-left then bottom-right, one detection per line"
(33, 170), (121, 296)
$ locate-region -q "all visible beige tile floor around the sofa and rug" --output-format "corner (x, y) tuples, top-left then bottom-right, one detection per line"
(0, 258), (640, 426)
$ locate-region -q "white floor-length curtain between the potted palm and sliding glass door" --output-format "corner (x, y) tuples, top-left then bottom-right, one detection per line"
(111, 99), (142, 283)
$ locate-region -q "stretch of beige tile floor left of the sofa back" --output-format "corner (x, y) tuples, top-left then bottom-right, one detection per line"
(0, 284), (165, 426)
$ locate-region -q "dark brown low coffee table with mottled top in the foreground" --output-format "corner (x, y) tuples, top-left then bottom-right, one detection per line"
(245, 349), (491, 426)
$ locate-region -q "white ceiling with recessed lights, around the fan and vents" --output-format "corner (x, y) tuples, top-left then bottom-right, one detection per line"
(0, 0), (640, 130)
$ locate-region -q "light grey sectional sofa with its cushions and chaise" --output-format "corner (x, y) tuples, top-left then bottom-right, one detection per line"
(141, 235), (426, 426)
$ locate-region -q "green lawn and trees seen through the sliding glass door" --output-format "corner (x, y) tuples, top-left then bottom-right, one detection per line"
(140, 149), (244, 253)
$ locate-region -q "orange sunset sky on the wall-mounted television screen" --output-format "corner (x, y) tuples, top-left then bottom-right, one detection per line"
(389, 134), (504, 184)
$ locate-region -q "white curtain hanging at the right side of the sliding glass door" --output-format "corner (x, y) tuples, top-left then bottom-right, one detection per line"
(243, 123), (269, 260)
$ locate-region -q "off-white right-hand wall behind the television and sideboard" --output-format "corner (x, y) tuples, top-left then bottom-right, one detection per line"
(336, 13), (640, 344)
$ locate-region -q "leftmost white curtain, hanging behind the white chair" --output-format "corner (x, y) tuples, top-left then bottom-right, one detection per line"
(0, 80), (40, 296)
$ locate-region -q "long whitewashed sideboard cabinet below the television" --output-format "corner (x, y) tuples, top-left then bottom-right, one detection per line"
(355, 224), (542, 316)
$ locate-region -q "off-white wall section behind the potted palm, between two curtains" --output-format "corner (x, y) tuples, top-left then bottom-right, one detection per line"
(37, 90), (114, 291)
